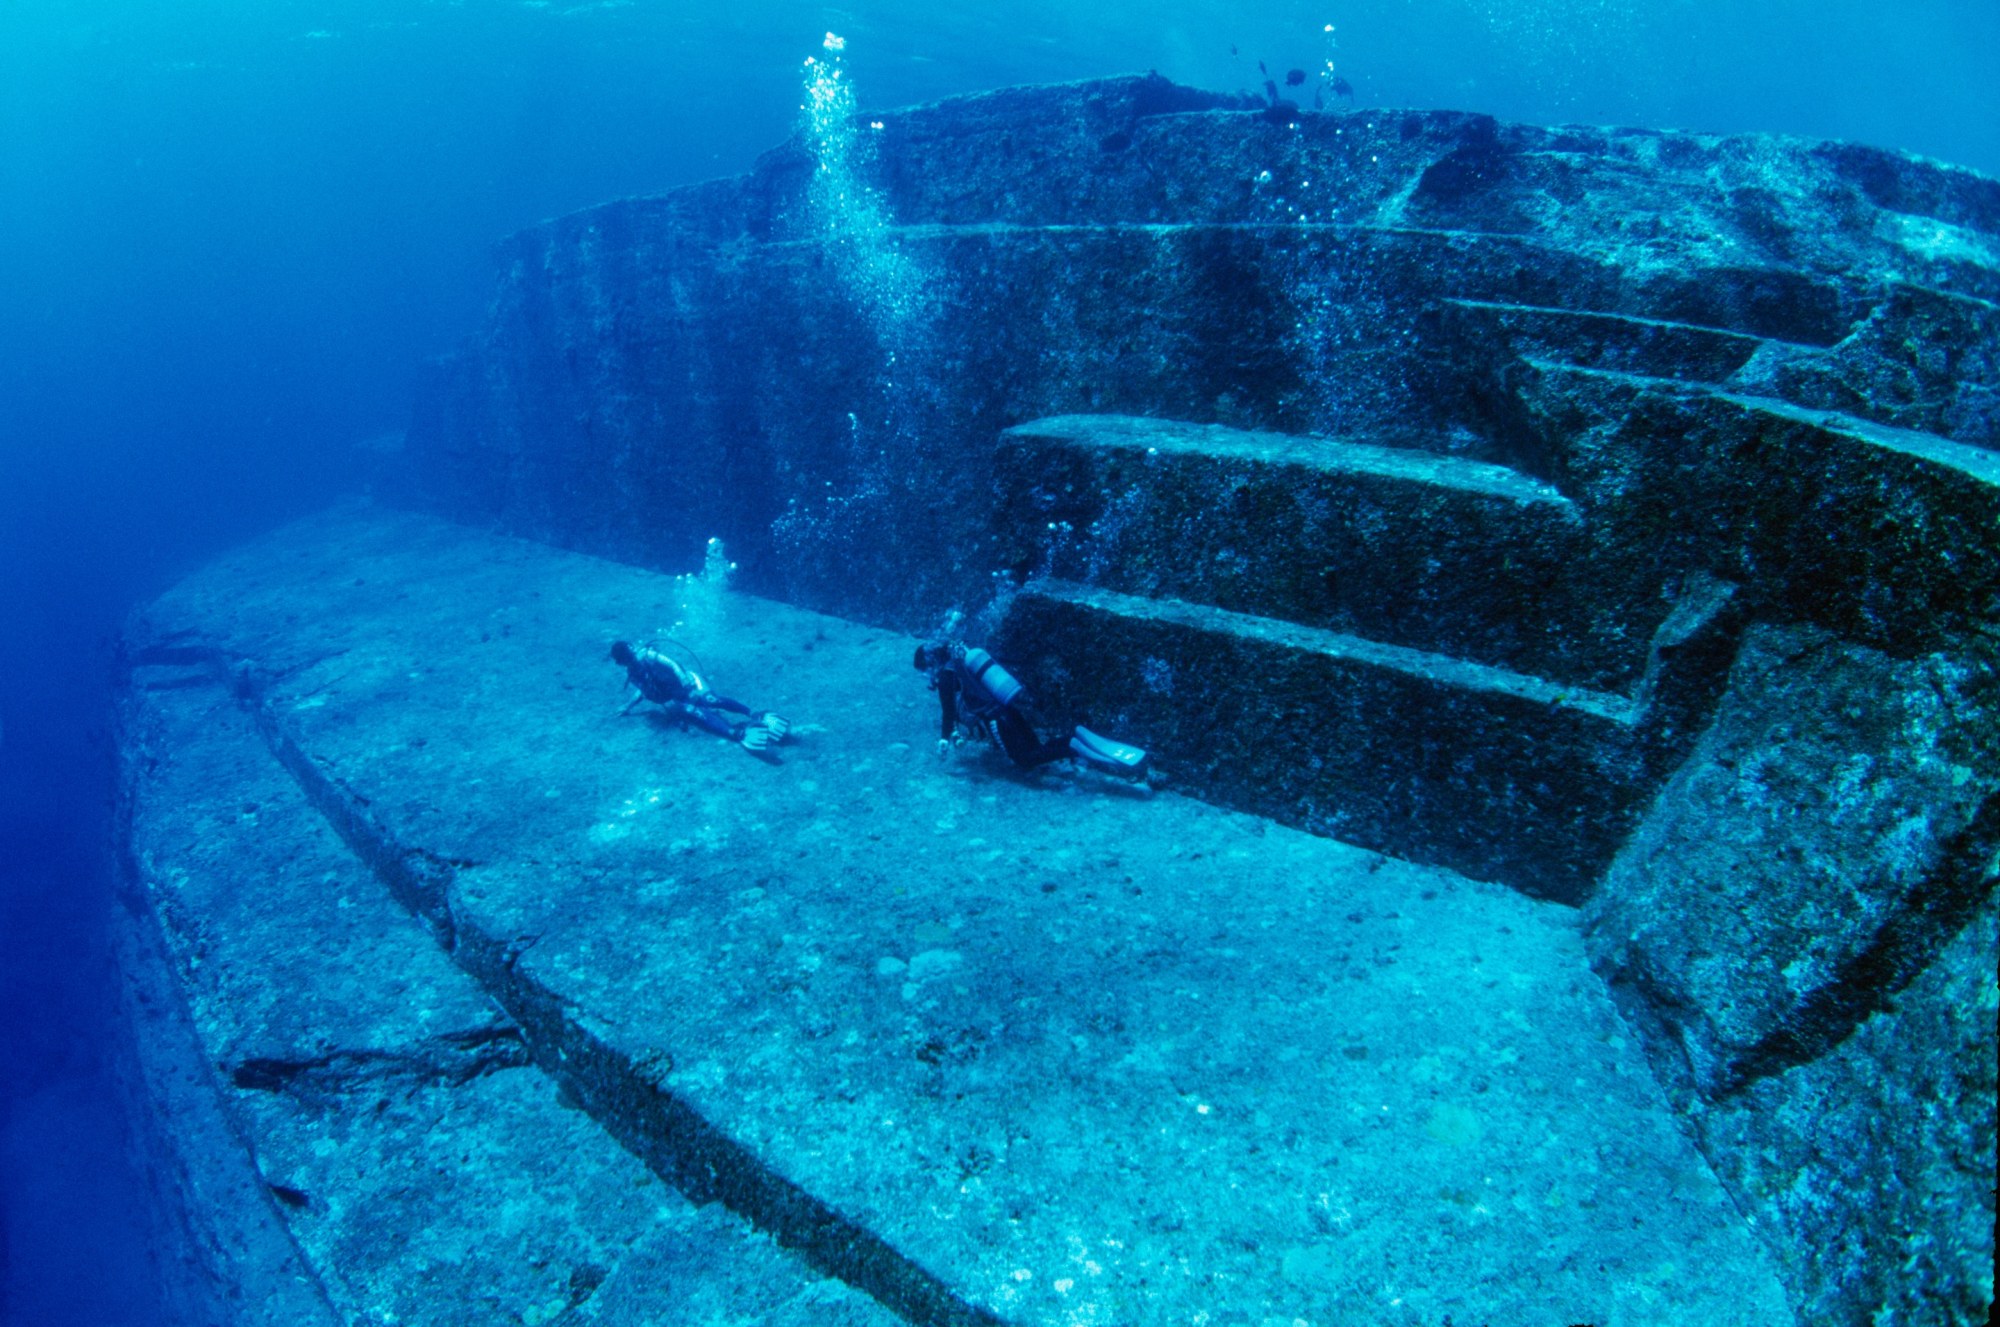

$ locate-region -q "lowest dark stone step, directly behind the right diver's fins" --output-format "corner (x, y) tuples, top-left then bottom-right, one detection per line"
(996, 582), (1736, 903)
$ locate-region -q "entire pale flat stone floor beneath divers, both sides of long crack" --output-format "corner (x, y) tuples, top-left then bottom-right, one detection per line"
(113, 510), (1788, 1327)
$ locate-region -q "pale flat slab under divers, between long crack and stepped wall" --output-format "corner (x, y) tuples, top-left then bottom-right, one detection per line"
(130, 508), (1792, 1327)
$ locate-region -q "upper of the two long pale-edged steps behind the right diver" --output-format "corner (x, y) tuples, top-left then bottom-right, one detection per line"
(994, 416), (1668, 685)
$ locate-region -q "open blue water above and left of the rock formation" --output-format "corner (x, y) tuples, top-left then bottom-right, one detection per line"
(0, 0), (2000, 1323)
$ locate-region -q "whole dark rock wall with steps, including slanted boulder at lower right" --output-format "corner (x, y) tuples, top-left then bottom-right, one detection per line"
(312, 78), (2000, 1323)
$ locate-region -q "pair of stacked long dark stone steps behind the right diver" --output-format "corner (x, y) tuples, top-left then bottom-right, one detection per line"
(994, 416), (1736, 901)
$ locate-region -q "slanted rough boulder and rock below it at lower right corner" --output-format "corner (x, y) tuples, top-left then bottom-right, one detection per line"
(1584, 628), (2000, 1323)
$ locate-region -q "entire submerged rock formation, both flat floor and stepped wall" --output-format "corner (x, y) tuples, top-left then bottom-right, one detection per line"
(126, 76), (2000, 1323)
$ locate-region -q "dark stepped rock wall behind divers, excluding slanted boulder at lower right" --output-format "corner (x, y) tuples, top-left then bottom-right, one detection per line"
(412, 78), (2000, 901)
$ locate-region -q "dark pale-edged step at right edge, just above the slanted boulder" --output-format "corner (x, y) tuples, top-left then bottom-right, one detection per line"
(1524, 360), (2000, 656)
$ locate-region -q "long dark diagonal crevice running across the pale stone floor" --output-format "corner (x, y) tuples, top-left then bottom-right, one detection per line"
(212, 656), (1002, 1327)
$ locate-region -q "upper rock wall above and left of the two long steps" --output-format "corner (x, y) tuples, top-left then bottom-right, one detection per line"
(412, 80), (2000, 639)
